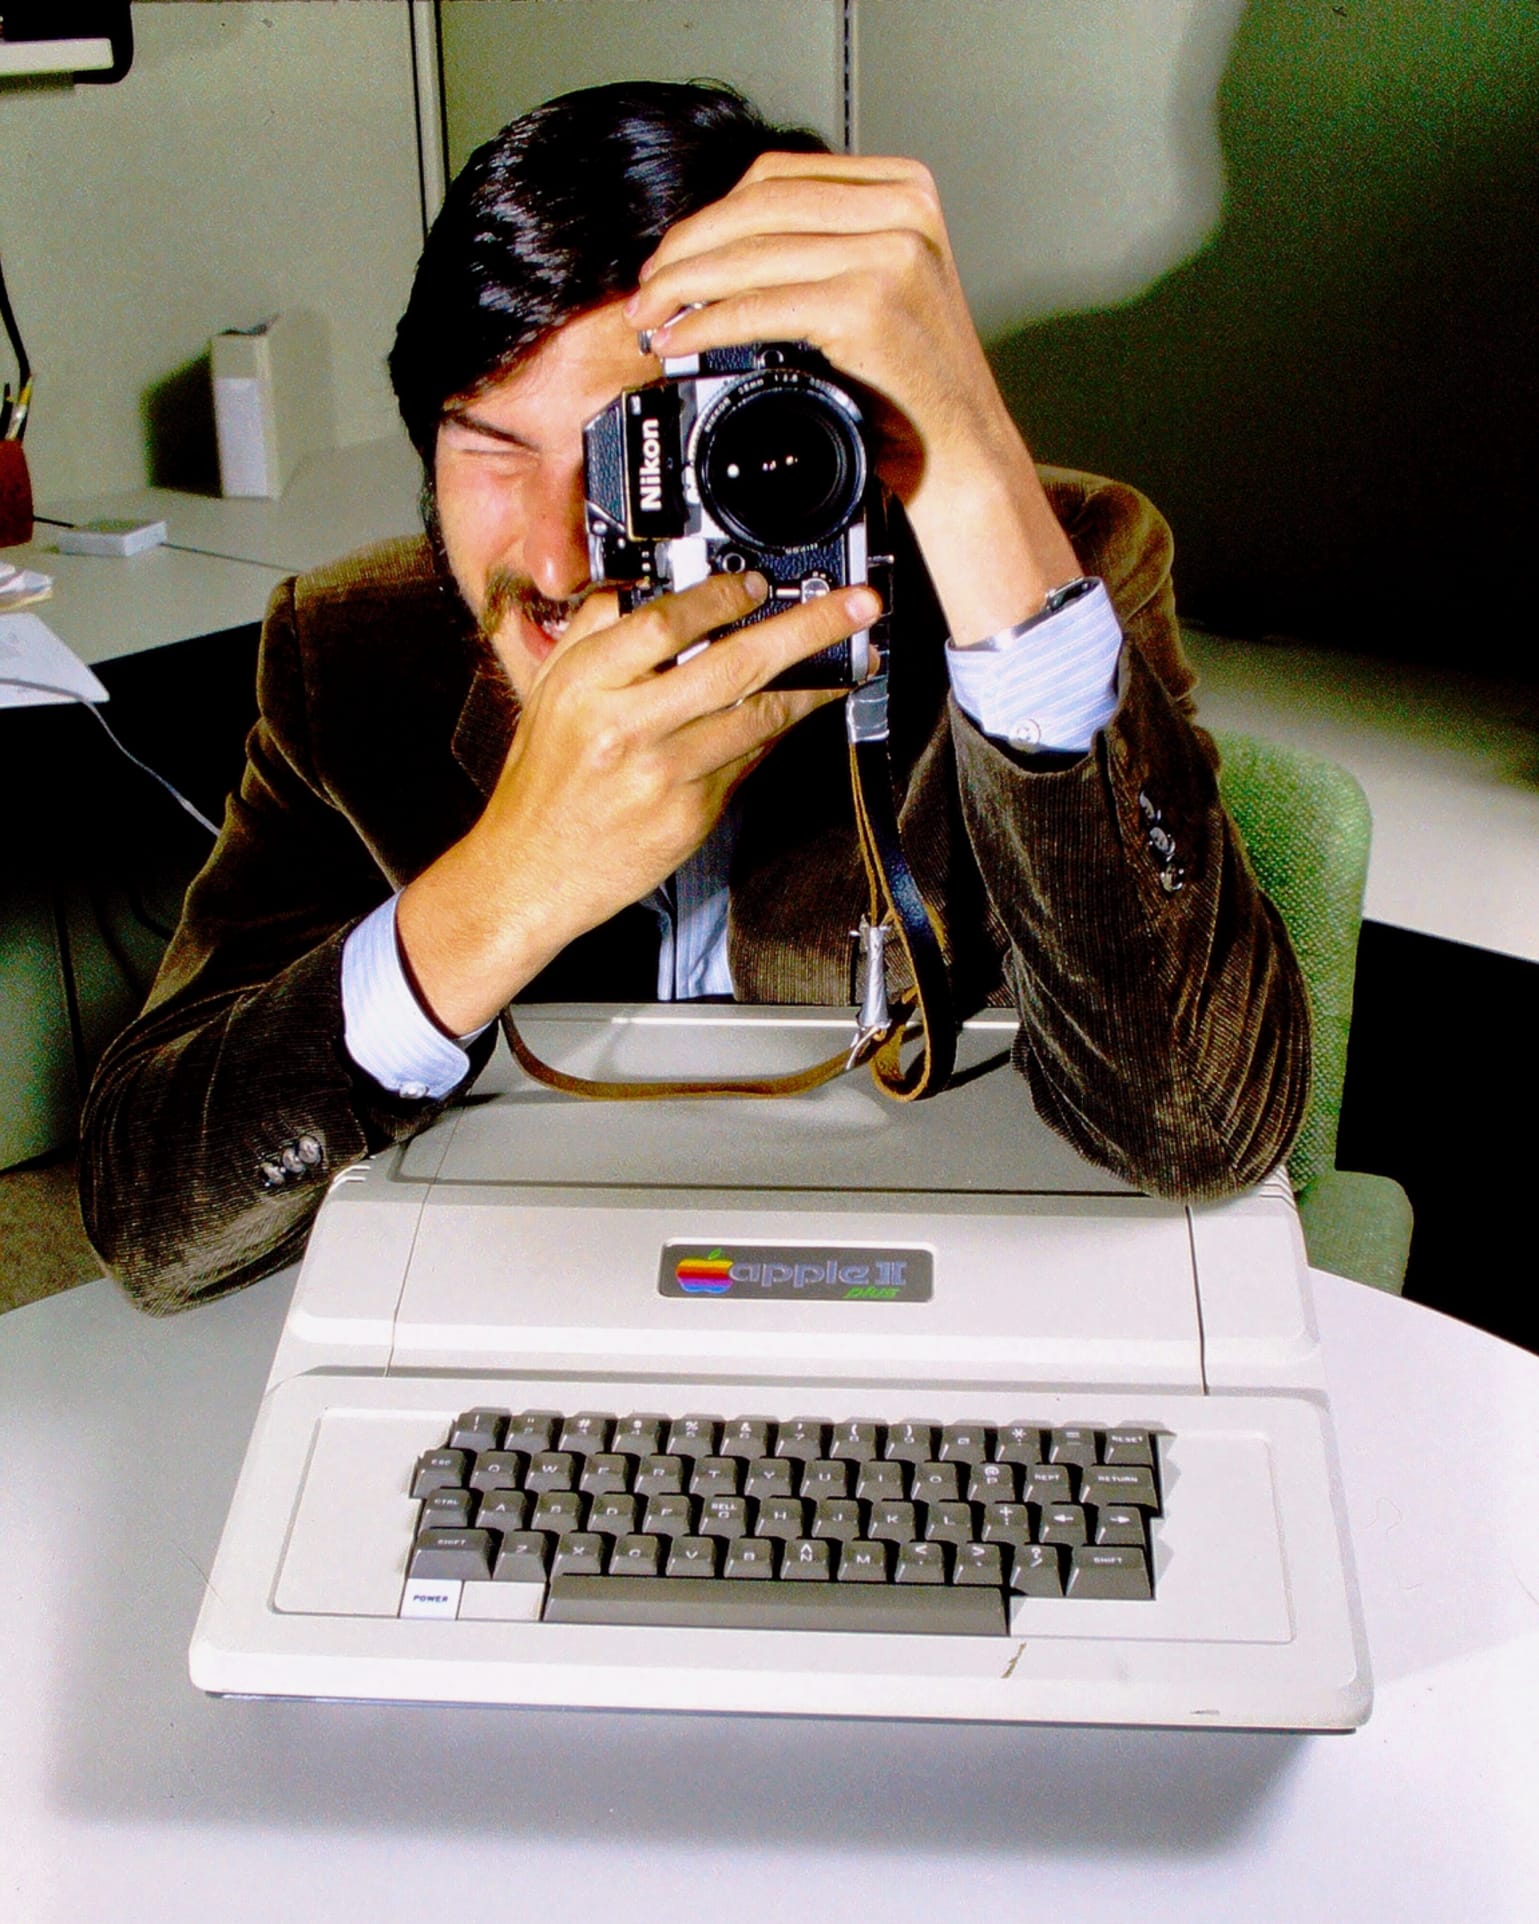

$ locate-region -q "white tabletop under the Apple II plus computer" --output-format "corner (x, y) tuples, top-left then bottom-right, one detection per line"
(0, 1276), (1539, 1924)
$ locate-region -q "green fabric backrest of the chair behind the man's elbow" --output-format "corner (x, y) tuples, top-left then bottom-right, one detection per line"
(1214, 729), (1374, 1191)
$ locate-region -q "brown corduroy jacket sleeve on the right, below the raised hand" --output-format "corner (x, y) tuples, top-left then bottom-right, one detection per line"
(948, 477), (1310, 1199)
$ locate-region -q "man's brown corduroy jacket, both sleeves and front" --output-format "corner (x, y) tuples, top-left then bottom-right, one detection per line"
(81, 469), (1308, 1312)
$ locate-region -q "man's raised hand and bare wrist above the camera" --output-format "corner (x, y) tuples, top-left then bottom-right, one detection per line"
(625, 154), (1079, 645)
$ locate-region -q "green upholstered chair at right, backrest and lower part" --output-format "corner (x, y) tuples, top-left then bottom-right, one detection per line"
(1214, 729), (1410, 1293)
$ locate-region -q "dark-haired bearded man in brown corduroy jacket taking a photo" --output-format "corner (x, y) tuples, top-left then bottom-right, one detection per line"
(81, 85), (1308, 1310)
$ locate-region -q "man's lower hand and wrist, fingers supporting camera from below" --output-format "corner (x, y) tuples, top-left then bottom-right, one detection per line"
(396, 575), (879, 1035)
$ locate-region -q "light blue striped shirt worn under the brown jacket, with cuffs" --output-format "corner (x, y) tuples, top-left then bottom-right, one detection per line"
(342, 583), (1122, 1101)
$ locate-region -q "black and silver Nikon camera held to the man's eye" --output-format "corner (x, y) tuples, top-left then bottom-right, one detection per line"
(583, 341), (891, 689)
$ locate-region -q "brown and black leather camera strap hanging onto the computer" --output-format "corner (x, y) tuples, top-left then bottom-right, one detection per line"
(502, 675), (956, 1102)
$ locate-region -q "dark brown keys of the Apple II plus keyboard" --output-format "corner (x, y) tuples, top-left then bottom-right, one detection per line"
(400, 1408), (1168, 1635)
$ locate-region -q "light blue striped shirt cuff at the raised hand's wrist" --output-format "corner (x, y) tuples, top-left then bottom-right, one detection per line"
(946, 581), (1122, 754)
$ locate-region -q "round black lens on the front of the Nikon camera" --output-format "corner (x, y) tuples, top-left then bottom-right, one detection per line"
(694, 373), (866, 554)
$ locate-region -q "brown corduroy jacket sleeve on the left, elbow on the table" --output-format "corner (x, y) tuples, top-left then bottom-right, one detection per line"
(81, 583), (489, 1314)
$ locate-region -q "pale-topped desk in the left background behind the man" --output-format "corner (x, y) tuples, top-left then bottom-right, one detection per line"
(0, 439), (419, 1170)
